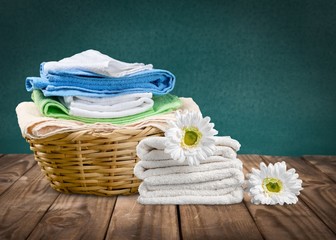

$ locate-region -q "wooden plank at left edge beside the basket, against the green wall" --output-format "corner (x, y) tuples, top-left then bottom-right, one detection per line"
(0, 154), (36, 195)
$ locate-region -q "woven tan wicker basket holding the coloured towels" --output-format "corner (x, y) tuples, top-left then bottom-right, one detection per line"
(27, 127), (163, 196)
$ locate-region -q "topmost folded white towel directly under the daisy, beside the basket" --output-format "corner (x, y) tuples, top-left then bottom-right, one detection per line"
(137, 136), (240, 161)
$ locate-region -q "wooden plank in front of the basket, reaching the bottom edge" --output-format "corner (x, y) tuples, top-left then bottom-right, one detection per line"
(28, 194), (116, 240)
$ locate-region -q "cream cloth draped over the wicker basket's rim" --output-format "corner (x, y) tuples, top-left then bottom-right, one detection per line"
(16, 98), (200, 139)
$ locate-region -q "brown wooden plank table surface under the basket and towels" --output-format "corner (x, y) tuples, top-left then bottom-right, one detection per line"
(0, 154), (336, 240)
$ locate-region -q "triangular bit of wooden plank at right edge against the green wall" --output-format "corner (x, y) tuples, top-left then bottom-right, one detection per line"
(303, 156), (336, 182)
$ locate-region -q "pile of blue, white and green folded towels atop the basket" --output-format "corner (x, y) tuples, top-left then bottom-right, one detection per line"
(26, 50), (182, 125)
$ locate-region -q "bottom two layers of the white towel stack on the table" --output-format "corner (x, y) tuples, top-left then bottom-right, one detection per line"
(138, 168), (244, 204)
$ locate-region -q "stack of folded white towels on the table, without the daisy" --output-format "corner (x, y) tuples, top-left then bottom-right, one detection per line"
(134, 137), (244, 204)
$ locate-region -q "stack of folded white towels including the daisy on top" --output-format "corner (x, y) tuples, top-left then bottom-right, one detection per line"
(134, 112), (244, 204)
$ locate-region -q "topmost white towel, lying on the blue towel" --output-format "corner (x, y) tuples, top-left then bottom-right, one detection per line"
(43, 49), (153, 77)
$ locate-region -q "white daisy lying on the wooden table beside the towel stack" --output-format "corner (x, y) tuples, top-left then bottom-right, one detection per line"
(247, 162), (303, 205)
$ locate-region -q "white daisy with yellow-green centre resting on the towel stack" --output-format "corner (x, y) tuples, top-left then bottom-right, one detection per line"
(165, 111), (218, 165)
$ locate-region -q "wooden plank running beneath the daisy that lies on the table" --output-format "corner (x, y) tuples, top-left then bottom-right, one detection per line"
(239, 155), (335, 239)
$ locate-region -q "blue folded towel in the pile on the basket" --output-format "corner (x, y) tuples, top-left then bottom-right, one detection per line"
(26, 50), (175, 97)
